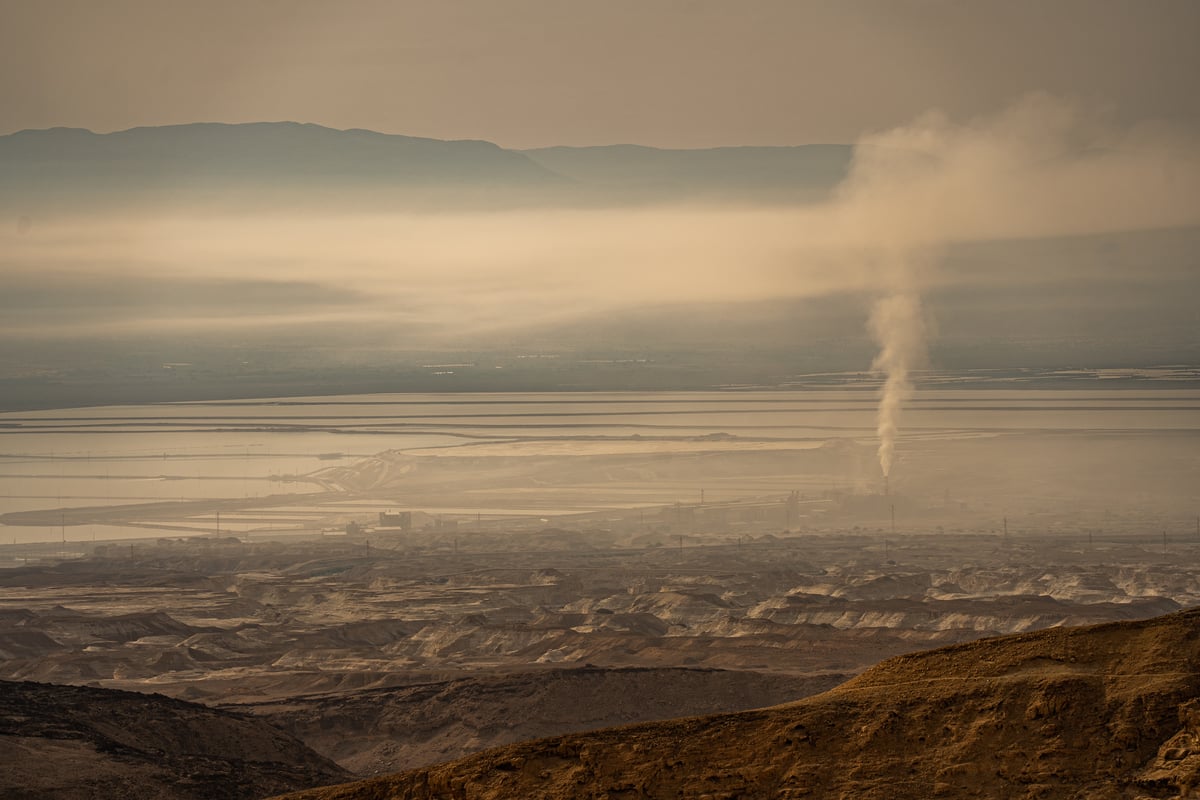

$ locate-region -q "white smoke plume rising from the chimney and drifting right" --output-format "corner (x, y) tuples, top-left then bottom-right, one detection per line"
(834, 95), (1200, 476)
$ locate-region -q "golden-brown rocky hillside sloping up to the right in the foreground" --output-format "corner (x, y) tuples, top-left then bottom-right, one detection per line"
(276, 610), (1200, 800)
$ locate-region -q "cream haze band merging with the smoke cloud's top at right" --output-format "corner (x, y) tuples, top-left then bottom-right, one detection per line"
(0, 96), (1200, 357)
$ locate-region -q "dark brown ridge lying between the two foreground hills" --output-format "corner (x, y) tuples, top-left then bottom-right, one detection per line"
(228, 666), (847, 775)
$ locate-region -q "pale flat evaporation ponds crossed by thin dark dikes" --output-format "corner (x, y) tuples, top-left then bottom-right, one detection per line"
(0, 389), (1200, 541)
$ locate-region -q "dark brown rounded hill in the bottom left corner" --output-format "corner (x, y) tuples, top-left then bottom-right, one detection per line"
(0, 681), (349, 800)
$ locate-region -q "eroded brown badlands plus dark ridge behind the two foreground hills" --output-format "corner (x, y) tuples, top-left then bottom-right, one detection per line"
(0, 527), (1200, 796)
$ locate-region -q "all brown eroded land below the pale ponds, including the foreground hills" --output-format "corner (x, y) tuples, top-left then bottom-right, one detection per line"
(0, 479), (1200, 798)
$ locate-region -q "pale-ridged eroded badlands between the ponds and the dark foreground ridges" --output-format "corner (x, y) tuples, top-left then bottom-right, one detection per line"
(0, 532), (1200, 716)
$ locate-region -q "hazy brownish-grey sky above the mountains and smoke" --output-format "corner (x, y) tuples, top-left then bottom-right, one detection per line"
(0, 0), (1200, 148)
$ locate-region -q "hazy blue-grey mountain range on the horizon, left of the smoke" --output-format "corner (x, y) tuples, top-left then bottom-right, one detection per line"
(0, 122), (853, 205)
